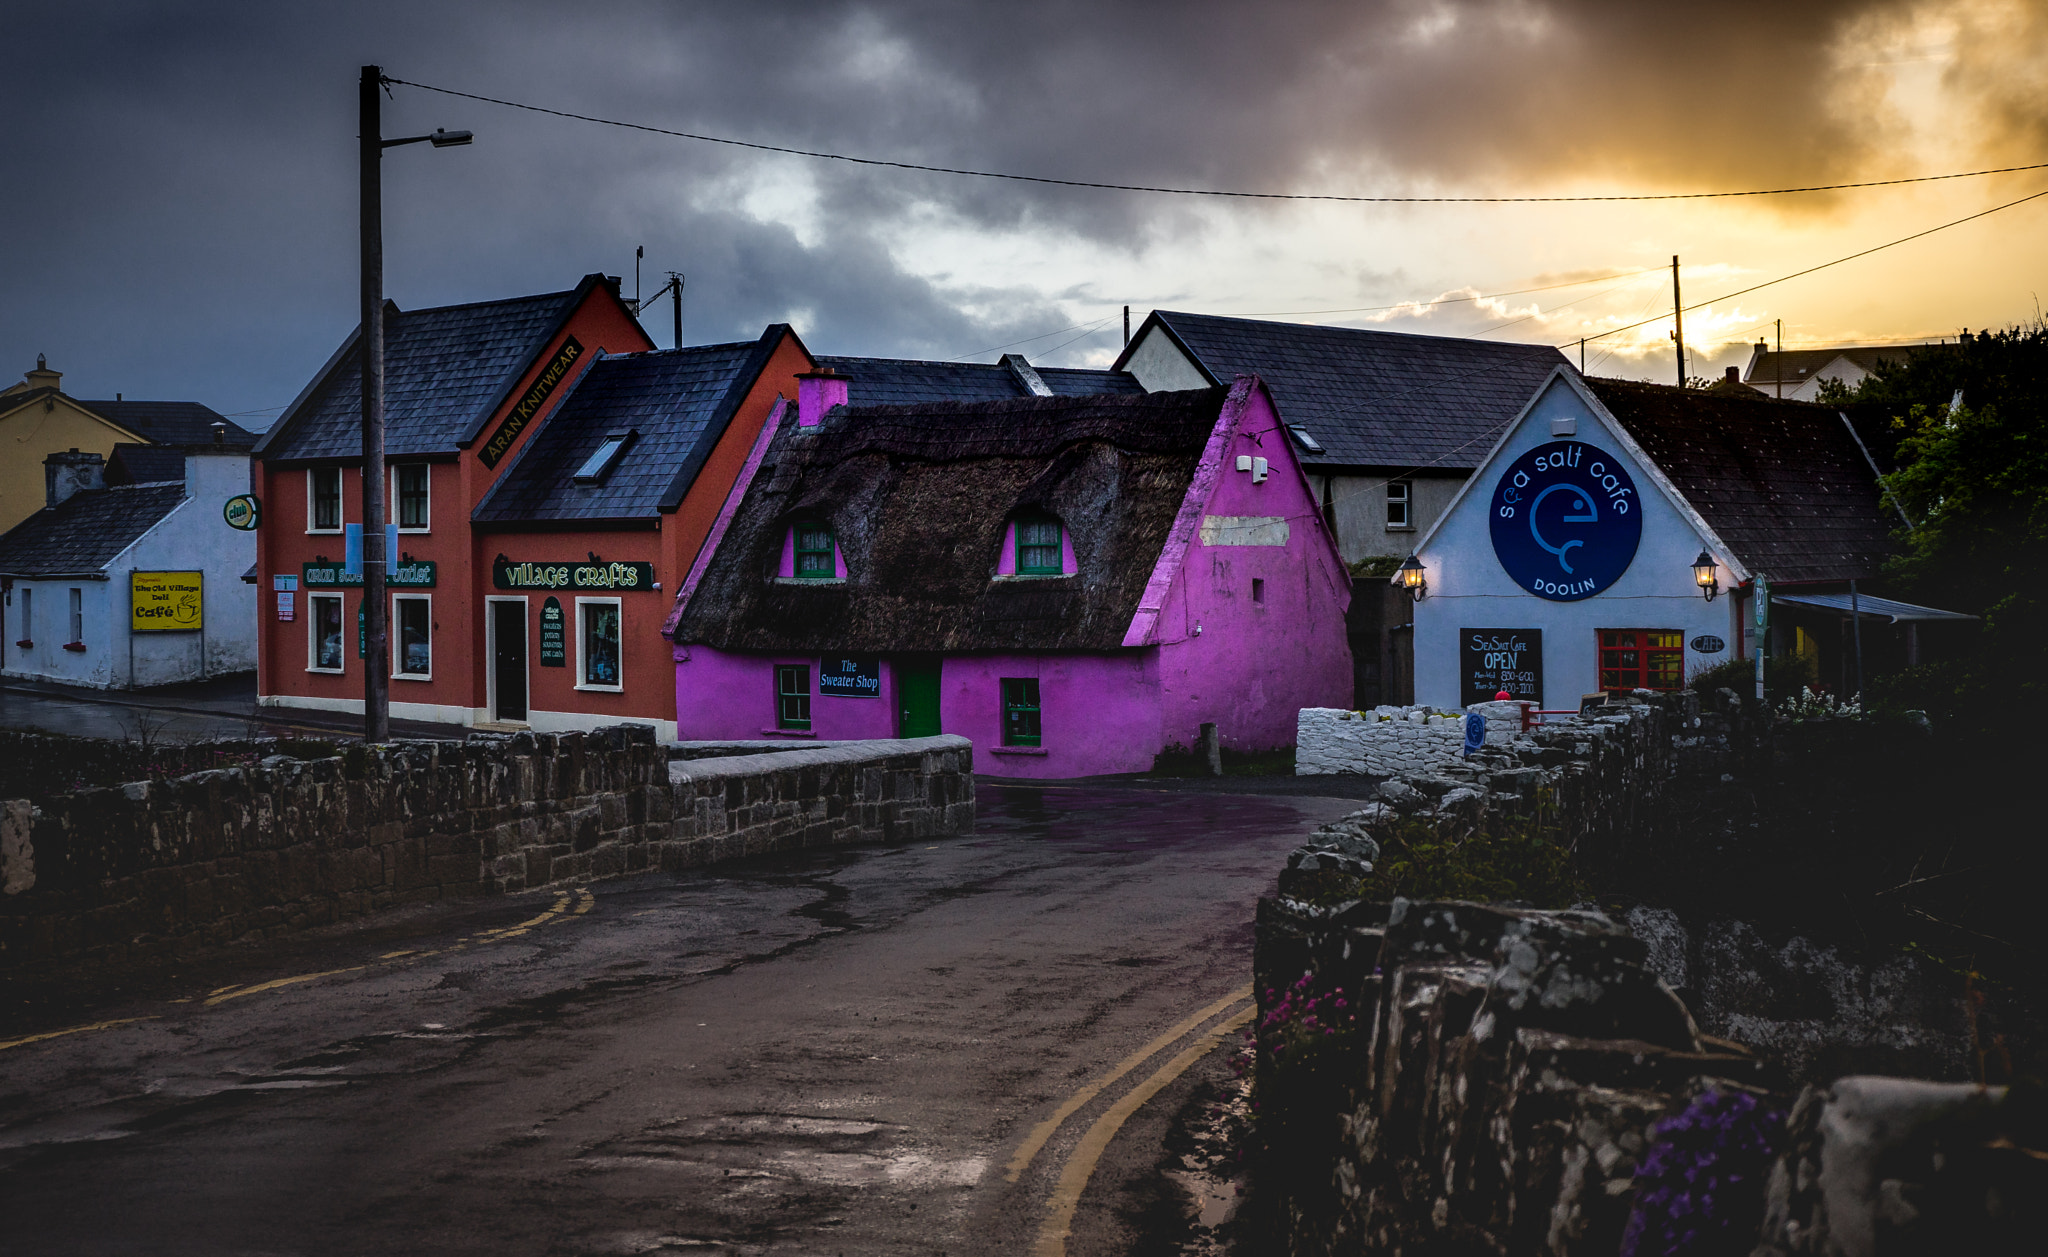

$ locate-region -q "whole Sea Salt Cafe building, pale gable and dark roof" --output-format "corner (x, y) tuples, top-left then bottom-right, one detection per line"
(1415, 369), (1916, 710)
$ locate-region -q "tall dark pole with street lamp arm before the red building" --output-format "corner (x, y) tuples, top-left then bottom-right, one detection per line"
(356, 66), (473, 741)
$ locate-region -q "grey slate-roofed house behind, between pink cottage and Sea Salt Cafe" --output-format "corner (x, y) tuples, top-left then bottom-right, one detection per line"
(1114, 309), (1567, 706)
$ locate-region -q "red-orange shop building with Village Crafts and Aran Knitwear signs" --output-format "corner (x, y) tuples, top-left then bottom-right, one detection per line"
(256, 274), (811, 739)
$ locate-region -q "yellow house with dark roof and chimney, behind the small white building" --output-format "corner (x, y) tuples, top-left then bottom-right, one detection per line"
(0, 354), (256, 532)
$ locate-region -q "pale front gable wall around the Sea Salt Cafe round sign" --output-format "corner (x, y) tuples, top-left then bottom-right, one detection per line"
(1415, 373), (1739, 708)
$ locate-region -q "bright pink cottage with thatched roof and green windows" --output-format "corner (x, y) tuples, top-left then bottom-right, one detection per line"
(664, 373), (1352, 778)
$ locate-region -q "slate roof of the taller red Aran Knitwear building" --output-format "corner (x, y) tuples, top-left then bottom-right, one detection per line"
(256, 274), (604, 461)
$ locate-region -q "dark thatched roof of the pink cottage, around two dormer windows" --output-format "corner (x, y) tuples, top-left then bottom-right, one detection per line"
(668, 389), (1227, 653)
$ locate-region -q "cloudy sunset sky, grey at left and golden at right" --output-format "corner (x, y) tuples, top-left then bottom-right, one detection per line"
(0, 0), (2048, 428)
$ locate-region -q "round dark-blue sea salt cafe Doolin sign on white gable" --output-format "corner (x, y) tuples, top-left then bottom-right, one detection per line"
(1491, 440), (1642, 602)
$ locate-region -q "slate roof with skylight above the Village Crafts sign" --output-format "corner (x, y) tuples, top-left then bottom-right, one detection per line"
(471, 323), (791, 522)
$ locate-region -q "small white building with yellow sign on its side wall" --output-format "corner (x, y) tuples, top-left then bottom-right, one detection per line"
(0, 448), (256, 690)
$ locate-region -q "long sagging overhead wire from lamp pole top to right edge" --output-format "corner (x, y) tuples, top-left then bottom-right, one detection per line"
(383, 78), (2048, 205)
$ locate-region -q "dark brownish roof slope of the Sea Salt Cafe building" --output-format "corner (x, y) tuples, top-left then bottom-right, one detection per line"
(1585, 379), (1896, 581)
